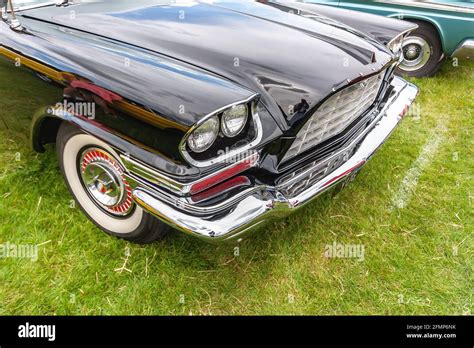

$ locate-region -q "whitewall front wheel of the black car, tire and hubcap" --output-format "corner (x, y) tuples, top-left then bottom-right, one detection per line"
(56, 123), (169, 244)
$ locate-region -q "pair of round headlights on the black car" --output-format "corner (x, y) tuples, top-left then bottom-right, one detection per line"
(187, 104), (249, 153)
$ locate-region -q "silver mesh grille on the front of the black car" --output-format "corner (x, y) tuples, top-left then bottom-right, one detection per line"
(283, 71), (385, 161)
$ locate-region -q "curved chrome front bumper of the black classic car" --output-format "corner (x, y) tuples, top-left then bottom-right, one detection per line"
(133, 77), (418, 241)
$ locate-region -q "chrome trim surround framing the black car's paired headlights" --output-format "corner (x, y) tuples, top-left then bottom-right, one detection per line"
(179, 94), (263, 168)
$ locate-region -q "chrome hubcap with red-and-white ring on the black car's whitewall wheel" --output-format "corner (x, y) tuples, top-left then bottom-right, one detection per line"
(79, 148), (133, 217)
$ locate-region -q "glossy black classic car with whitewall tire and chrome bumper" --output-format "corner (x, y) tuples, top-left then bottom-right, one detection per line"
(0, 0), (418, 243)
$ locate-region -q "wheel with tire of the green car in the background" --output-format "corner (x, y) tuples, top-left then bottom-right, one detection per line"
(398, 22), (443, 77)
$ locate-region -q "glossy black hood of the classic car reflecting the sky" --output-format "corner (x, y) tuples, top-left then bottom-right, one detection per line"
(23, 0), (393, 128)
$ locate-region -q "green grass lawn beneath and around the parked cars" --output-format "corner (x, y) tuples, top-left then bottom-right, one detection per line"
(0, 62), (474, 315)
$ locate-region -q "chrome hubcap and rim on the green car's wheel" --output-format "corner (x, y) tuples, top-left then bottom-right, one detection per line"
(400, 36), (431, 71)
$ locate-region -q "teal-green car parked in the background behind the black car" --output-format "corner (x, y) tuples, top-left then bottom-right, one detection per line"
(284, 0), (474, 77)
